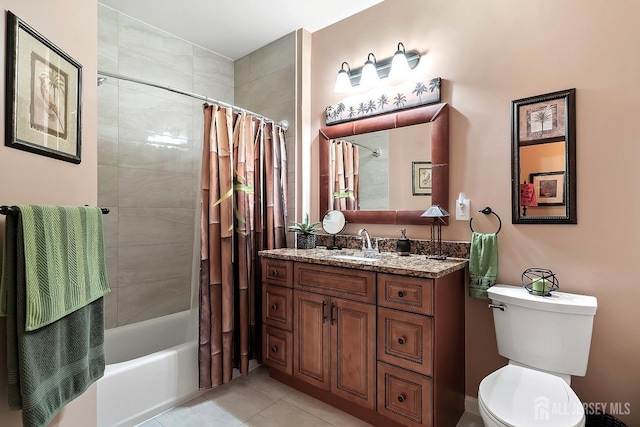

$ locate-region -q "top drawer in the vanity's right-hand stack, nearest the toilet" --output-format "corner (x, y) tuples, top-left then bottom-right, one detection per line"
(378, 273), (433, 315)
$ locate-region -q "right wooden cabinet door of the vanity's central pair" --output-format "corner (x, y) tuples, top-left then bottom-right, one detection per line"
(331, 298), (376, 410)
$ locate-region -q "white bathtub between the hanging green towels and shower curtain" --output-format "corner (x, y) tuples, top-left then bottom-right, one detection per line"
(97, 311), (199, 427)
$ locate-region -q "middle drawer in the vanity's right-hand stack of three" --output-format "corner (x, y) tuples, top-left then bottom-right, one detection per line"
(378, 307), (433, 376)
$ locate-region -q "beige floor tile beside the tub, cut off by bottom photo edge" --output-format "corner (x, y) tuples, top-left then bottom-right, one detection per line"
(155, 397), (242, 427)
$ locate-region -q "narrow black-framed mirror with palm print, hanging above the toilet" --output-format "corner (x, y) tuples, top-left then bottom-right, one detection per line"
(511, 89), (578, 224)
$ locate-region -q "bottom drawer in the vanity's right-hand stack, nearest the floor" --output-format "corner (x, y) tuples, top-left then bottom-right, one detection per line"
(378, 362), (432, 427)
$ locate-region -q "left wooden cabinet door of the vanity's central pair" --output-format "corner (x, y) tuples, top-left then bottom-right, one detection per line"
(293, 291), (331, 390)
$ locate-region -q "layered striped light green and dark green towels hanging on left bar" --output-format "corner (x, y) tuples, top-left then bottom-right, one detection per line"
(0, 206), (109, 427)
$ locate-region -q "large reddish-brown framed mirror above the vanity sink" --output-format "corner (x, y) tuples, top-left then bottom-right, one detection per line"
(319, 103), (449, 224)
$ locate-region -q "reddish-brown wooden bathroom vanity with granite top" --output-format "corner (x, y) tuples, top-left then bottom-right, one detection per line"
(260, 249), (467, 427)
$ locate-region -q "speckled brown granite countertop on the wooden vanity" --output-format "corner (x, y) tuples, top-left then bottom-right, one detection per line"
(258, 247), (468, 279)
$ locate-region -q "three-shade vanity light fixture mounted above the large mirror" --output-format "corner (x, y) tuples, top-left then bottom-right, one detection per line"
(333, 42), (420, 93)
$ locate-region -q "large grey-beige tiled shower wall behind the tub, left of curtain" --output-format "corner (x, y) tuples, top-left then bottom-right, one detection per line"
(98, 5), (234, 328)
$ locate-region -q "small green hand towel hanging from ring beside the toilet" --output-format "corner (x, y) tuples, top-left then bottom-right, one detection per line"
(469, 232), (498, 299)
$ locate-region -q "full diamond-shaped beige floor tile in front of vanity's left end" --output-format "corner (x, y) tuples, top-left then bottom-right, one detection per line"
(202, 379), (279, 421)
